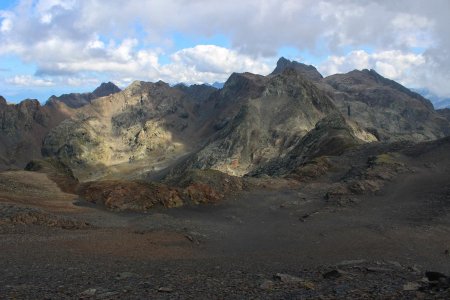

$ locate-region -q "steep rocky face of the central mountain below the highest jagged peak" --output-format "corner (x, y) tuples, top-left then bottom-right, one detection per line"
(165, 68), (376, 176)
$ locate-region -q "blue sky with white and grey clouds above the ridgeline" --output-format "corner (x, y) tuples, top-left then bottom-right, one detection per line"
(0, 0), (450, 102)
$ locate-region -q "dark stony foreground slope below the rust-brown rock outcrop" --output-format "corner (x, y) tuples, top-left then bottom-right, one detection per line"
(0, 140), (450, 299)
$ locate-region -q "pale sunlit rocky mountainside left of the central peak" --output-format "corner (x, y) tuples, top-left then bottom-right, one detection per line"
(43, 81), (216, 179)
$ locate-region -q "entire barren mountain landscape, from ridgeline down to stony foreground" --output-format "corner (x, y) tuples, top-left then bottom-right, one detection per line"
(0, 58), (450, 299)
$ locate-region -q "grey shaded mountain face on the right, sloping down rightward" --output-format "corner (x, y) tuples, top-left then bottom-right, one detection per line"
(321, 70), (449, 141)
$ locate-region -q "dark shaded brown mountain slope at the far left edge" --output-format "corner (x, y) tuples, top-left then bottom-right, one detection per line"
(0, 97), (71, 169)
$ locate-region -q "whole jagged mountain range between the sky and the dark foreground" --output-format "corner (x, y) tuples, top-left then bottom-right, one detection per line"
(0, 58), (450, 206)
